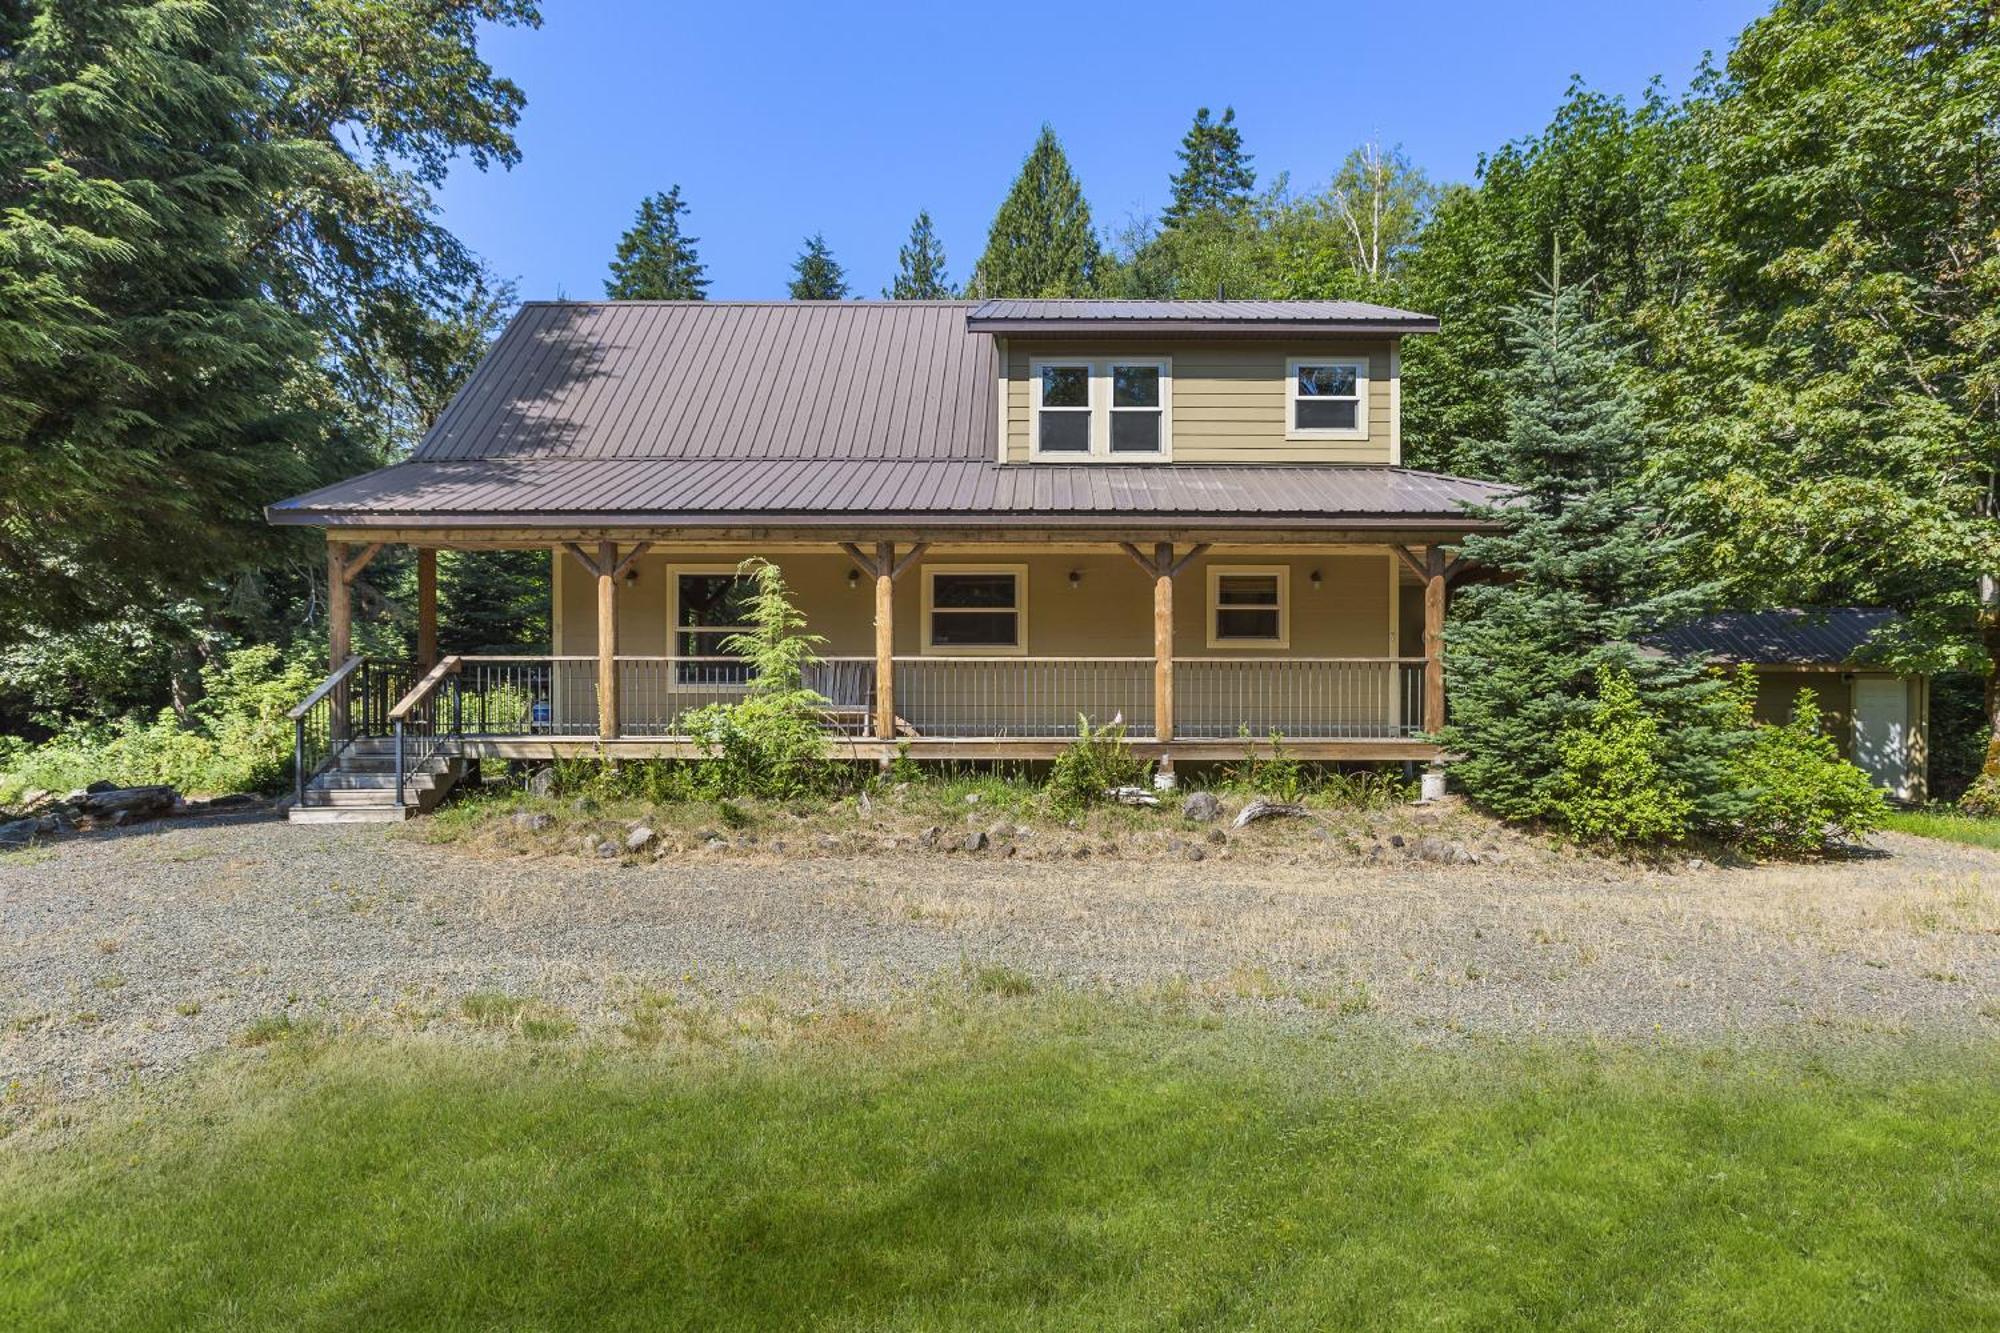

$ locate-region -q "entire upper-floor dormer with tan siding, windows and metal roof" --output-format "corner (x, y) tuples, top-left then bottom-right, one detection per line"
(966, 300), (1438, 466)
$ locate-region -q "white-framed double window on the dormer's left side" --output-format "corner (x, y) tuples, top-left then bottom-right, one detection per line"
(1030, 356), (1174, 462)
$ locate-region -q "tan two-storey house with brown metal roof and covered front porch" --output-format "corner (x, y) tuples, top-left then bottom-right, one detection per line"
(268, 300), (1502, 813)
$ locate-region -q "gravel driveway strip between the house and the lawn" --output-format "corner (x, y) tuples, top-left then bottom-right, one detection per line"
(0, 819), (2000, 1113)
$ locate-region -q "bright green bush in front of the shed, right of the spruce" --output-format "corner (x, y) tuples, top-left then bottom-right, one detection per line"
(1732, 667), (1888, 857)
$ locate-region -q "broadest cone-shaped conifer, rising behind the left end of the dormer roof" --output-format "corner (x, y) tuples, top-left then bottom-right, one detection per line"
(972, 124), (1098, 298)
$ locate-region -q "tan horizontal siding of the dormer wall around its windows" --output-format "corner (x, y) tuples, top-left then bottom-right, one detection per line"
(1006, 338), (1398, 464)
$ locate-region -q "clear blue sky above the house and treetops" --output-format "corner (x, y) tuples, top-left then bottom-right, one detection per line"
(442, 0), (1768, 298)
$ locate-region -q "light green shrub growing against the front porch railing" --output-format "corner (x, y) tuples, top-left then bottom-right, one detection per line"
(684, 560), (834, 799)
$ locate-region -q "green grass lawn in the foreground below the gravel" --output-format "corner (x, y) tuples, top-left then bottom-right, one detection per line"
(0, 997), (2000, 1329)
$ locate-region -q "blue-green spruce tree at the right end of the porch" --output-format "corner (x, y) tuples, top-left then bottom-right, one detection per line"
(1444, 274), (1738, 825)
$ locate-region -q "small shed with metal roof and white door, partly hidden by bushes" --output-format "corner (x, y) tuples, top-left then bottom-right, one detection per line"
(1652, 606), (1930, 803)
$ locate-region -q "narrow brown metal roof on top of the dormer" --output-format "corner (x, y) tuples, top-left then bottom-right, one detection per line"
(966, 300), (1438, 334)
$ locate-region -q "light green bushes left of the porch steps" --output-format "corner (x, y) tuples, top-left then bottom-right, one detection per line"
(0, 644), (316, 801)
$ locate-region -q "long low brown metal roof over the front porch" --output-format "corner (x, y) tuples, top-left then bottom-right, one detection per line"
(270, 458), (1504, 526)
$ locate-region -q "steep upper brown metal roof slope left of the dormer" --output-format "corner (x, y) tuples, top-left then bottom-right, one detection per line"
(412, 300), (996, 462)
